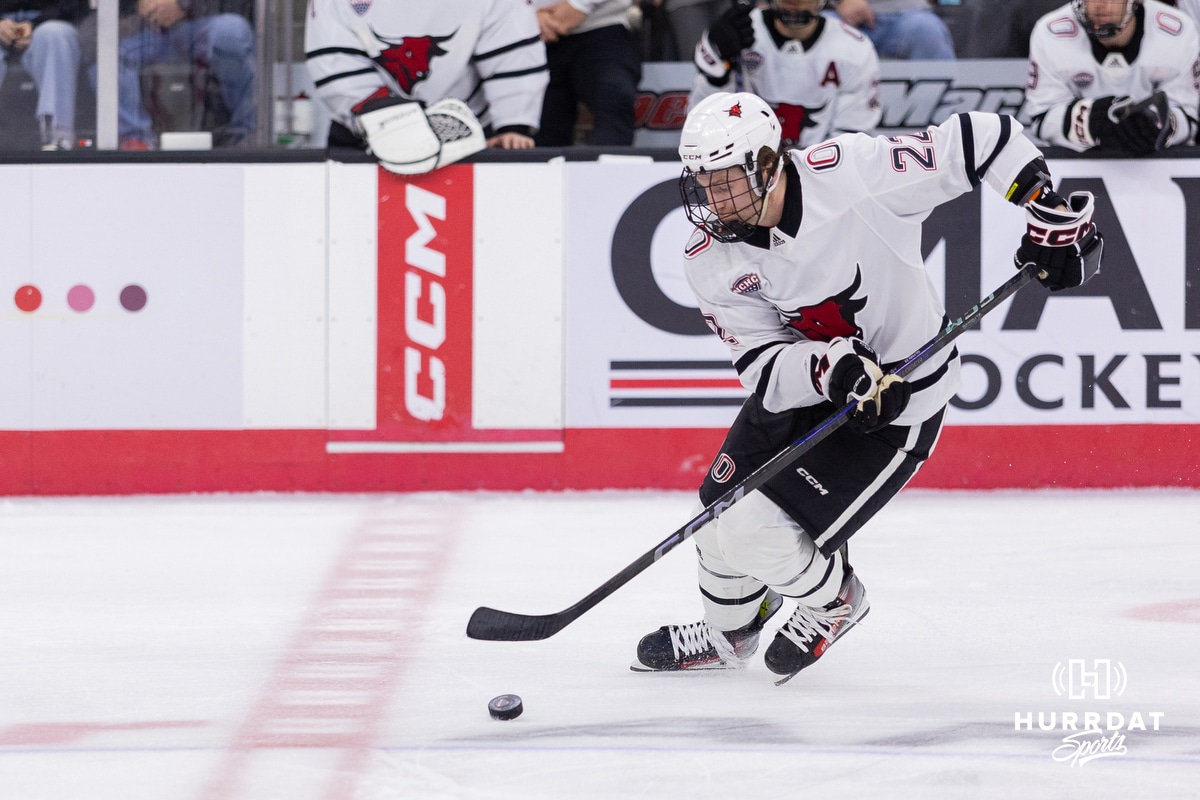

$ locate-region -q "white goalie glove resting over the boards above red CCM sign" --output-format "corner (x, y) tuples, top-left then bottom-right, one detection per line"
(356, 96), (487, 175)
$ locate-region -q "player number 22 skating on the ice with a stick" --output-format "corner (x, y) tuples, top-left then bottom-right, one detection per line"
(632, 92), (1103, 679)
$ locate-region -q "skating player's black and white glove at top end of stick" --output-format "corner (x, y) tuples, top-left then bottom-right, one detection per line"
(1013, 192), (1104, 291)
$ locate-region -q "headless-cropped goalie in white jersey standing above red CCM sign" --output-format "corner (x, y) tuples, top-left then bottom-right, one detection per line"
(305, 0), (548, 174)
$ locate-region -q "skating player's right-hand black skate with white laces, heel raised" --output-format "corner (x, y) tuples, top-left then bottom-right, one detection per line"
(763, 565), (871, 686)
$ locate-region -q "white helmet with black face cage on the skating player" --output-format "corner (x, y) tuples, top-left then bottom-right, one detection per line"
(679, 92), (782, 241)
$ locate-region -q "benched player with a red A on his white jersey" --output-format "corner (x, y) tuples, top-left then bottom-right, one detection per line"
(688, 0), (883, 146)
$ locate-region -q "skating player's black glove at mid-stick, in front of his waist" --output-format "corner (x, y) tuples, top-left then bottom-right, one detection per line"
(810, 338), (912, 433)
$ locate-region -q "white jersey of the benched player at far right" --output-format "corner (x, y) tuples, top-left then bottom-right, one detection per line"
(1025, 0), (1200, 151)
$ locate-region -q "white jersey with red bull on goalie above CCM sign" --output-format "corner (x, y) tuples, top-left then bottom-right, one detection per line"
(305, 0), (550, 131)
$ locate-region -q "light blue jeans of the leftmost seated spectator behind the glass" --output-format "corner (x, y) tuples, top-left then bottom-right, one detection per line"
(0, 11), (79, 146)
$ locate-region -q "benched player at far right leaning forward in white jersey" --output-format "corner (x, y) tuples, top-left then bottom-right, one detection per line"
(1025, 0), (1200, 156)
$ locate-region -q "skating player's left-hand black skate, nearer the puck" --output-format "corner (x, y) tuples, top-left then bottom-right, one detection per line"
(629, 589), (784, 672)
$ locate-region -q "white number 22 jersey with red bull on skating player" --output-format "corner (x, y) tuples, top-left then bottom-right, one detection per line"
(684, 112), (1042, 425)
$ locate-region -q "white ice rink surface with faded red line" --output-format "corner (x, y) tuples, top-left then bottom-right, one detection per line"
(0, 491), (1200, 800)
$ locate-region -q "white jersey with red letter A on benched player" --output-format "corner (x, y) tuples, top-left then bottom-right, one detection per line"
(688, 8), (883, 148)
